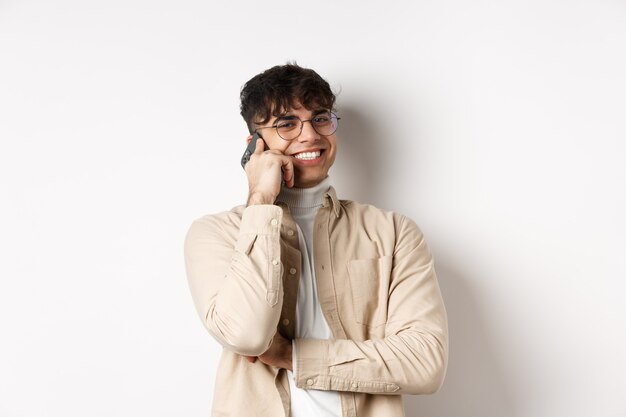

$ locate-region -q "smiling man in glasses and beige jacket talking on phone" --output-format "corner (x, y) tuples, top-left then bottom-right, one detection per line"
(185, 64), (448, 417)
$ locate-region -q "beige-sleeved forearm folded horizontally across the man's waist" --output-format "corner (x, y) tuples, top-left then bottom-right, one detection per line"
(294, 324), (448, 394)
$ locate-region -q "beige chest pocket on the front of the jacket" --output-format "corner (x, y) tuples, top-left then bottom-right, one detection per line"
(348, 256), (392, 327)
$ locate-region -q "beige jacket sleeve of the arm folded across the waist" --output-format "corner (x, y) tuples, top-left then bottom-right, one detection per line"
(294, 217), (448, 394)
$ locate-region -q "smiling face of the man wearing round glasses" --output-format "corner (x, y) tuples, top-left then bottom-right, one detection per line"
(251, 103), (337, 188)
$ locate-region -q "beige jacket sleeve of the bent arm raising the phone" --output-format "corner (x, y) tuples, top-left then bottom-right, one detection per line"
(185, 205), (283, 356)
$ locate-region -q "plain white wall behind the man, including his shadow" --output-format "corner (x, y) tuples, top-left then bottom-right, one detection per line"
(0, 0), (626, 417)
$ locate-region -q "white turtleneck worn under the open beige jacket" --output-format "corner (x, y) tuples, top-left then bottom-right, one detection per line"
(277, 177), (341, 417)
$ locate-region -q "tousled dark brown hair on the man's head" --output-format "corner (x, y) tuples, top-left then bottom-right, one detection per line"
(240, 62), (336, 133)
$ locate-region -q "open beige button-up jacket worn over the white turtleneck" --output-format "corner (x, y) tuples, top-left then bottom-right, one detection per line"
(185, 187), (448, 417)
